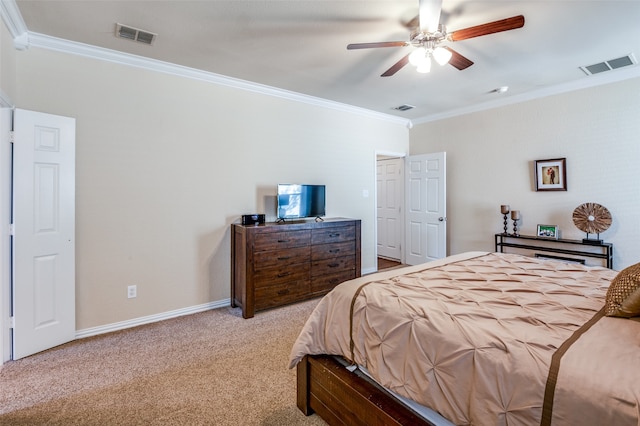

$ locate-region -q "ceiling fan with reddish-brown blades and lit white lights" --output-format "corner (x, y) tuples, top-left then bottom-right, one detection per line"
(347, 0), (524, 77)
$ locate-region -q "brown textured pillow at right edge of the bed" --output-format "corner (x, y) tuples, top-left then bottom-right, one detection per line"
(605, 263), (640, 318)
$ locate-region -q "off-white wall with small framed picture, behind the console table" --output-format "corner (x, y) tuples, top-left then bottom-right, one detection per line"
(410, 78), (640, 269)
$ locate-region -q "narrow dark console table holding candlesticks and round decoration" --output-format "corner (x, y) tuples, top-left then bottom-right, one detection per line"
(495, 234), (613, 269)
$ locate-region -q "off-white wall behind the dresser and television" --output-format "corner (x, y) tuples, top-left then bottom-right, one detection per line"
(16, 47), (409, 330)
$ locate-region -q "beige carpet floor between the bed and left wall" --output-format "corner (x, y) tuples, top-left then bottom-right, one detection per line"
(0, 299), (325, 426)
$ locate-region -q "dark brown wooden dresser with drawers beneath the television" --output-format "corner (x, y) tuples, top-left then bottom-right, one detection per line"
(231, 218), (361, 318)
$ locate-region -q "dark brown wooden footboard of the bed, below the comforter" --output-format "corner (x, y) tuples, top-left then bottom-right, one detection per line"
(297, 355), (434, 426)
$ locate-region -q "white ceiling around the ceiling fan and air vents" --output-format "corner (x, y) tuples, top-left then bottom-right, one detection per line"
(7, 0), (640, 122)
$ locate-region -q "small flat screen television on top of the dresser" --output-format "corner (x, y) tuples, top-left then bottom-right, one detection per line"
(278, 183), (326, 219)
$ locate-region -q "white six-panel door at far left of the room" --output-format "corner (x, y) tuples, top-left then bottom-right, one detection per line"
(12, 109), (75, 359)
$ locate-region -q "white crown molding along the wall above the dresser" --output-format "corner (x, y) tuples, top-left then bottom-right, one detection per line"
(28, 32), (410, 127)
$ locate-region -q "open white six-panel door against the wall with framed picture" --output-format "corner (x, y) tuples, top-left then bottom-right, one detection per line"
(405, 152), (447, 265)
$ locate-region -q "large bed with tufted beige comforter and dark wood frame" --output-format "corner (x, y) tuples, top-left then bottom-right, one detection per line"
(290, 252), (640, 425)
